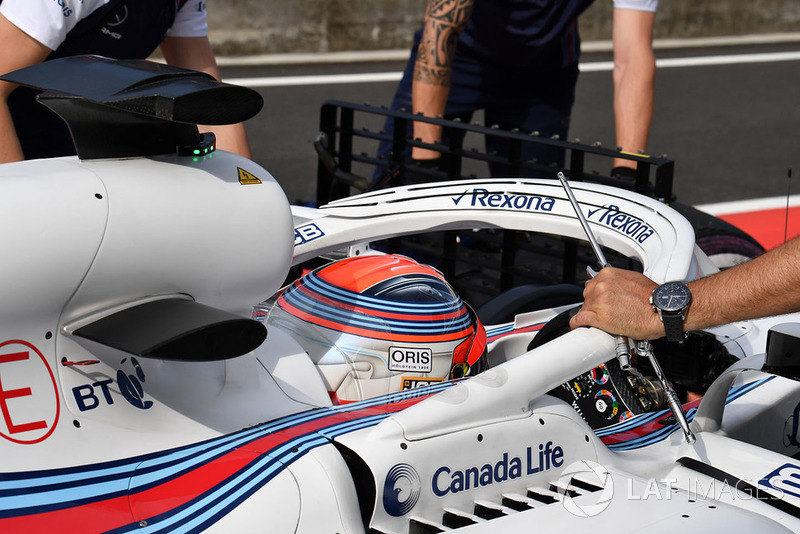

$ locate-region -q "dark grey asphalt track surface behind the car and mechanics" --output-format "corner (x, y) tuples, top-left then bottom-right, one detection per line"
(222, 40), (800, 230)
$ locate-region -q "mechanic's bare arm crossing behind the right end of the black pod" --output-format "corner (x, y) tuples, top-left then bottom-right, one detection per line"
(161, 37), (251, 158)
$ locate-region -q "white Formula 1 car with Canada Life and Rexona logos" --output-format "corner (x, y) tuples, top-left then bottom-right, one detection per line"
(0, 57), (800, 533)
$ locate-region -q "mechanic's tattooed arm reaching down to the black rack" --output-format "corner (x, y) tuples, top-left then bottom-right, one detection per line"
(411, 0), (475, 159)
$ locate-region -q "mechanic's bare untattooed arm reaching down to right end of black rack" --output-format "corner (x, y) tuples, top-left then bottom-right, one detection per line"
(612, 8), (656, 172)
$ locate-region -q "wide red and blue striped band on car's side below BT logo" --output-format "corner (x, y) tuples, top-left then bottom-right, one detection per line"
(0, 384), (450, 532)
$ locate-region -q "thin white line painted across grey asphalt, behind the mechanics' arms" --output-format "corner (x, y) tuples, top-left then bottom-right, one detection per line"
(225, 51), (800, 87)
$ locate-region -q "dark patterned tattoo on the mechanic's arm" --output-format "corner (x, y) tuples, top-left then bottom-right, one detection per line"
(414, 0), (475, 86)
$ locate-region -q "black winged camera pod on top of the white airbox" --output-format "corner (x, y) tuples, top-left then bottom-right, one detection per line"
(0, 56), (264, 159)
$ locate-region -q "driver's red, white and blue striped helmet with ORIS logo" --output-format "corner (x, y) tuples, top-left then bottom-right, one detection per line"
(267, 254), (488, 403)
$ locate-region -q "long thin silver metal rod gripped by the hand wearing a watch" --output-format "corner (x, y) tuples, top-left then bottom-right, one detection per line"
(558, 172), (696, 445)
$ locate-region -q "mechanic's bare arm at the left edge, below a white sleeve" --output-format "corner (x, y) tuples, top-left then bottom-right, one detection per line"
(0, 13), (51, 163)
